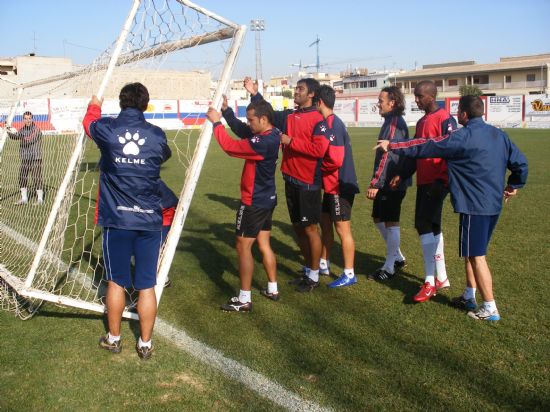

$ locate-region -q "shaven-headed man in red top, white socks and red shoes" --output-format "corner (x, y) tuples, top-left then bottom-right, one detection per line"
(390, 80), (462, 302)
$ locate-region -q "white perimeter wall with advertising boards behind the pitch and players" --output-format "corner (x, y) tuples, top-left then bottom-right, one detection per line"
(0, 95), (550, 133)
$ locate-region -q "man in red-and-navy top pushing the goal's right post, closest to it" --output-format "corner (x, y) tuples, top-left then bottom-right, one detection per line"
(206, 99), (281, 312)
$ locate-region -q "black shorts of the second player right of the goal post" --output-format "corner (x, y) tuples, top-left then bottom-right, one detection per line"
(285, 182), (321, 227)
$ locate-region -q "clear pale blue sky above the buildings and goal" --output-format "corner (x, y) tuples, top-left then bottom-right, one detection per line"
(0, 0), (550, 78)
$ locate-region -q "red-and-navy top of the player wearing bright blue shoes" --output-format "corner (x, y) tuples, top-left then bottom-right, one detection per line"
(314, 114), (359, 195)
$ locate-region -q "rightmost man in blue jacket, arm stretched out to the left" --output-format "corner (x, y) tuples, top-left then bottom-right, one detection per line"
(377, 96), (528, 321)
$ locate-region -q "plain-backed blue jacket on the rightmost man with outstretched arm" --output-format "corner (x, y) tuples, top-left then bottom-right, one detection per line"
(389, 117), (528, 215)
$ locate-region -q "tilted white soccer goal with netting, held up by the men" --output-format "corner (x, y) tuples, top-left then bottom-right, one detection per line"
(0, 0), (246, 319)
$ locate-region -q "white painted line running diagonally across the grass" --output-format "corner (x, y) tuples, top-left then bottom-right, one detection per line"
(0, 222), (331, 412)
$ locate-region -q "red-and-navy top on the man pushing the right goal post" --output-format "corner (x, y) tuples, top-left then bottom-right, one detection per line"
(214, 119), (281, 209)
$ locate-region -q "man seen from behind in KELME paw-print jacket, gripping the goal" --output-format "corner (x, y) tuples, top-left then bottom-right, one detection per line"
(83, 83), (171, 359)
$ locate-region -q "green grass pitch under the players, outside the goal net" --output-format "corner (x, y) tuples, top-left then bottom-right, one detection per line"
(0, 129), (550, 411)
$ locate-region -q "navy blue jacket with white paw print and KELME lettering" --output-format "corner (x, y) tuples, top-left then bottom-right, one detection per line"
(83, 105), (171, 230)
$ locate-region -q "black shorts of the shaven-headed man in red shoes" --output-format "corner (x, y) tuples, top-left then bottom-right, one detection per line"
(414, 180), (449, 234)
